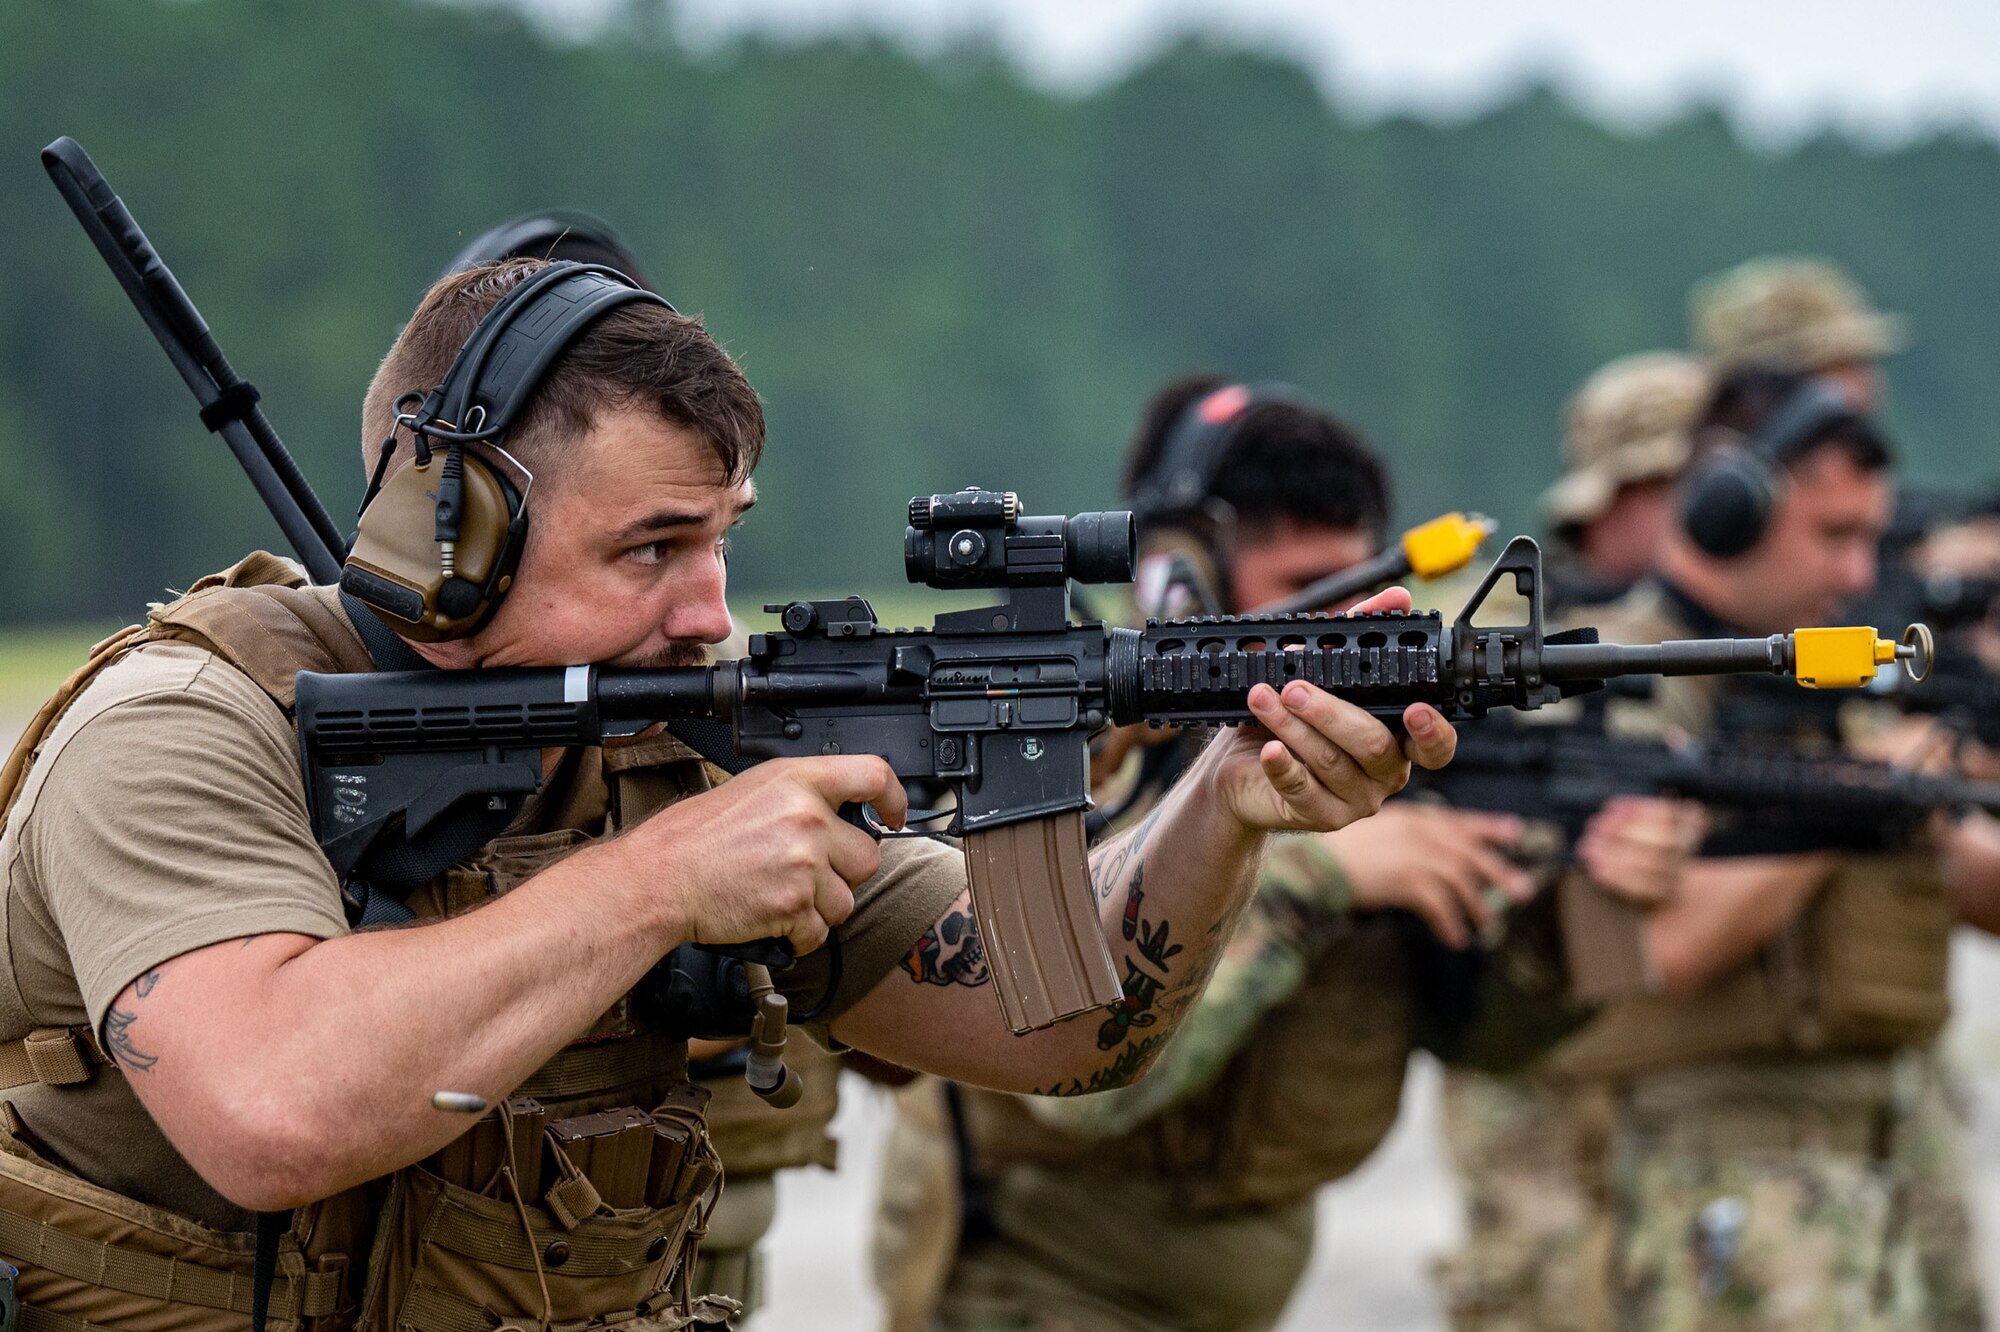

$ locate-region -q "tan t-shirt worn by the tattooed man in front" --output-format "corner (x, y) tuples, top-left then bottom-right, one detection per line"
(0, 642), (966, 1230)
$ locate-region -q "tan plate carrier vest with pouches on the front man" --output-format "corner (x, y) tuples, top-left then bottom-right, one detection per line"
(0, 552), (732, 1332)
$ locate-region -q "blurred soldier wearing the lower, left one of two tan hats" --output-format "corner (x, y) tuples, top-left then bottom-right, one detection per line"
(1438, 352), (1708, 1332)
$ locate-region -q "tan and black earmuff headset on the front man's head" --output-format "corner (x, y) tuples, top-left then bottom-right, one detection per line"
(340, 260), (674, 642)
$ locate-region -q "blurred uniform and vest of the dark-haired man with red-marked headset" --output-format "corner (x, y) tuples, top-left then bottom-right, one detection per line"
(874, 836), (1410, 1332)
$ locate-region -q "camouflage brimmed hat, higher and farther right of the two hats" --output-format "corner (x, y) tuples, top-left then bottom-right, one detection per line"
(1688, 256), (1906, 374)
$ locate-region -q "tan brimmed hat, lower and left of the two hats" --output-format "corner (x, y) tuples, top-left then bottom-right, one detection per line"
(1542, 352), (1710, 528)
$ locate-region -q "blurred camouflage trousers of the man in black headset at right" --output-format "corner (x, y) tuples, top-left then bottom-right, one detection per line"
(1612, 1050), (1986, 1332)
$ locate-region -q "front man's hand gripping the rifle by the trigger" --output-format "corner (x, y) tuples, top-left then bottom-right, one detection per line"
(604, 754), (908, 954)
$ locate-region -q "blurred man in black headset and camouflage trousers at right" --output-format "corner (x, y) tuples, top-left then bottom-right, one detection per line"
(1548, 360), (2000, 1330)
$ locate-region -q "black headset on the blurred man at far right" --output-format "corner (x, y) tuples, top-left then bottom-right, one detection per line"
(1680, 376), (1874, 560)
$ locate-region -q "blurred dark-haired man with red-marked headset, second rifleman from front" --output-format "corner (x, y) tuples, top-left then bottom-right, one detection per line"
(876, 378), (1640, 1332)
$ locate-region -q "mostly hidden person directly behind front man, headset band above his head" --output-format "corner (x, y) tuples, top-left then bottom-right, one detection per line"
(440, 208), (840, 1328)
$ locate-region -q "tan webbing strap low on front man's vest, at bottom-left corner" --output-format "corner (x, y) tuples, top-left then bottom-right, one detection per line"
(0, 1210), (342, 1322)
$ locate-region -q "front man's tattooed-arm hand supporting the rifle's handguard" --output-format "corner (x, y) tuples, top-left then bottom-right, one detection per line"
(1214, 588), (1458, 832)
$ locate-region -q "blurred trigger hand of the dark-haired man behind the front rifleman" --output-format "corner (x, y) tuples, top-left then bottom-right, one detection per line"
(1320, 800), (1534, 948)
